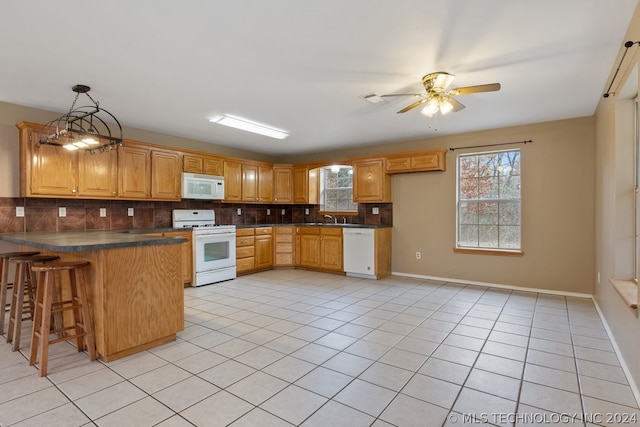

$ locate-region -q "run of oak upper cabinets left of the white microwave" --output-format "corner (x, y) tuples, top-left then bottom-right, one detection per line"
(18, 122), (182, 200)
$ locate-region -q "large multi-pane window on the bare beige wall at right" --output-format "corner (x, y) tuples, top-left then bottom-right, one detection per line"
(457, 150), (521, 251)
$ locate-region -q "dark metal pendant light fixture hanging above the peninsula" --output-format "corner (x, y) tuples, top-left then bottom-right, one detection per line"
(38, 85), (123, 152)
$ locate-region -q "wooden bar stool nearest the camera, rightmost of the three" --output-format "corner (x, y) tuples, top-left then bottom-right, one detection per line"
(29, 261), (96, 377)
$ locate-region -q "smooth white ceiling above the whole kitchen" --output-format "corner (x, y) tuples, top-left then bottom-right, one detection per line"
(0, 0), (638, 155)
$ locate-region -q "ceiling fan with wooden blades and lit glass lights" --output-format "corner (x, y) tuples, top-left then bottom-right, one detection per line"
(380, 71), (500, 117)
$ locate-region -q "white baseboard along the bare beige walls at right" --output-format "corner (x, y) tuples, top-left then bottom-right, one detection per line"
(391, 271), (640, 406)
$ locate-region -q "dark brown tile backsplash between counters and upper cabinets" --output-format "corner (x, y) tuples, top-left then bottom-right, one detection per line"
(0, 197), (393, 233)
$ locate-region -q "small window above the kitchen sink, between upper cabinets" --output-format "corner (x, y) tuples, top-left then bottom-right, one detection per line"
(320, 165), (358, 212)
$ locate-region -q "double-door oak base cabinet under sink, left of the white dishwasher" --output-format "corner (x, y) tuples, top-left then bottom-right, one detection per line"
(296, 226), (343, 272)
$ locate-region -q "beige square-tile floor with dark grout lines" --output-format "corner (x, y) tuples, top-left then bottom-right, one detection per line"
(0, 270), (640, 427)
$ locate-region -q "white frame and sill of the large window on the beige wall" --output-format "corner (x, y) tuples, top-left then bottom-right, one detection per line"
(454, 148), (524, 256)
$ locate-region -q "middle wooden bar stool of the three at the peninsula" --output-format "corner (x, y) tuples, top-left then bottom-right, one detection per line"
(7, 255), (60, 351)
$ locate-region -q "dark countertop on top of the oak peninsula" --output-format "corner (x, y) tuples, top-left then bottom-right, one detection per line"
(0, 229), (187, 252)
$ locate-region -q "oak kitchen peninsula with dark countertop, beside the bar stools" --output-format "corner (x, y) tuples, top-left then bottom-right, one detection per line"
(0, 231), (186, 362)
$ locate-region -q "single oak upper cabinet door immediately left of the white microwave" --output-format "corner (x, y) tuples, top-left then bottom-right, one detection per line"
(151, 150), (182, 201)
